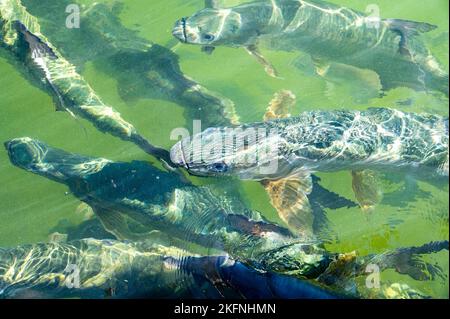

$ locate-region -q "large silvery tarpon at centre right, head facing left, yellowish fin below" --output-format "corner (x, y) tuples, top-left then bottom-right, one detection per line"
(171, 108), (449, 231)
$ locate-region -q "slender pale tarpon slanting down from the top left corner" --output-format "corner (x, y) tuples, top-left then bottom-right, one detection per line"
(0, 0), (170, 162)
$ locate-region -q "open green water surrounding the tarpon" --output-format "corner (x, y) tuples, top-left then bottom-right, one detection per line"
(0, 0), (449, 298)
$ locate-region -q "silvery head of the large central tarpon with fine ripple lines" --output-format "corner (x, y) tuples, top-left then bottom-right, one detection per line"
(170, 127), (280, 180)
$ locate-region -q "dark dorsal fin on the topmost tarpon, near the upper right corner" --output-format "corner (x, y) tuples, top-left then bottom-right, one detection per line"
(384, 19), (437, 57)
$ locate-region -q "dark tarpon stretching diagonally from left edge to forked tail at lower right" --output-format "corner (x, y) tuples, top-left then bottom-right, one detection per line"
(5, 138), (448, 296)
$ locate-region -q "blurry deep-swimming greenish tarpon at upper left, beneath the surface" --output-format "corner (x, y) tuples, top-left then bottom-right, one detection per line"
(19, 0), (238, 126)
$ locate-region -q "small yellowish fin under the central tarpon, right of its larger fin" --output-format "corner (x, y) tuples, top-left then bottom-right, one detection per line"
(352, 169), (383, 211)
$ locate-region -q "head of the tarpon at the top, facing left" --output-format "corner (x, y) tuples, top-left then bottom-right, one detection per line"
(172, 8), (245, 47)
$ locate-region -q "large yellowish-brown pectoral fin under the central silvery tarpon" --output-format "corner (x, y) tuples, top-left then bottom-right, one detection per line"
(261, 172), (314, 237)
